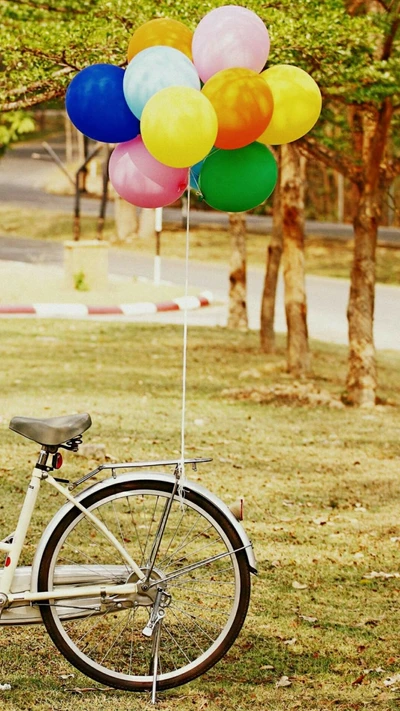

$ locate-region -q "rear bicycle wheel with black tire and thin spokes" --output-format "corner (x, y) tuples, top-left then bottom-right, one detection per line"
(38, 479), (250, 691)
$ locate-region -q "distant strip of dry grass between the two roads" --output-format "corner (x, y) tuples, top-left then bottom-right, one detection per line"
(0, 205), (400, 284)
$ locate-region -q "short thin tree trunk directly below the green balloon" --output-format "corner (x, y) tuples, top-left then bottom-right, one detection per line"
(228, 212), (248, 331)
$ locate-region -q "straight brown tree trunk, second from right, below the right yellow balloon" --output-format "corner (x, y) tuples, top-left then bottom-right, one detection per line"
(281, 143), (310, 375)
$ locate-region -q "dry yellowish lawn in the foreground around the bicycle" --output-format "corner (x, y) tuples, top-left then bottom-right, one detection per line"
(0, 320), (400, 711)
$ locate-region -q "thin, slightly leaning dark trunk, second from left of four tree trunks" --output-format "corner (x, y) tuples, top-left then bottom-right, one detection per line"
(260, 152), (283, 353)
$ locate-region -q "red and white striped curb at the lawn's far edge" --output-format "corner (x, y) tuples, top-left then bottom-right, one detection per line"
(0, 291), (213, 318)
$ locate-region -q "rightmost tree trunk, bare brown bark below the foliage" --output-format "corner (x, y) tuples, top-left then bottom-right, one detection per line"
(347, 100), (393, 407)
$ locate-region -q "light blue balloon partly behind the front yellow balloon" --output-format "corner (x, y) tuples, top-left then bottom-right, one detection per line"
(123, 46), (200, 119)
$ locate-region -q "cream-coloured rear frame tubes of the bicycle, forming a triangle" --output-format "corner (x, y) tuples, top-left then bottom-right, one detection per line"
(0, 467), (146, 610)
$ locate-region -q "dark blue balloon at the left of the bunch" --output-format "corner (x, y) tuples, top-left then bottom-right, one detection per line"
(65, 64), (140, 143)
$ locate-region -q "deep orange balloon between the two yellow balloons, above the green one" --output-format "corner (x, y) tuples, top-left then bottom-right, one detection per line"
(202, 68), (274, 150)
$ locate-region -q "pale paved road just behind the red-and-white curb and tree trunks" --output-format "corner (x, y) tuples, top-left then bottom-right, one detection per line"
(0, 237), (400, 350)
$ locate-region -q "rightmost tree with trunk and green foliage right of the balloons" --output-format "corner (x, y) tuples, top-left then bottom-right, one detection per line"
(254, 0), (400, 405)
